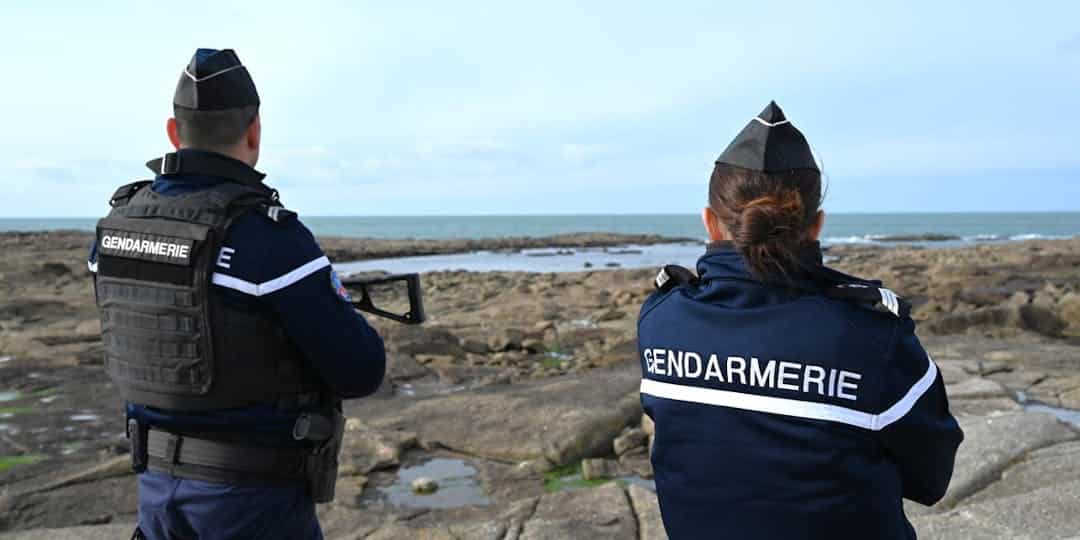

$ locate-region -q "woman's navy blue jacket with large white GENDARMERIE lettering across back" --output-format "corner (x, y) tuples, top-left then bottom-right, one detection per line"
(638, 244), (963, 540)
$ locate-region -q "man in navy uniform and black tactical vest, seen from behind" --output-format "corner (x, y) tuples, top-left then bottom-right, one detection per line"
(89, 49), (386, 540)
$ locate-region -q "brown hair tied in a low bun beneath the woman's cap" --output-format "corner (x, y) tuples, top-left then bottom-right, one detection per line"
(708, 163), (822, 279)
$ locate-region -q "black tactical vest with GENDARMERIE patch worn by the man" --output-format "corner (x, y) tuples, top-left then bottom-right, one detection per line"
(95, 154), (321, 410)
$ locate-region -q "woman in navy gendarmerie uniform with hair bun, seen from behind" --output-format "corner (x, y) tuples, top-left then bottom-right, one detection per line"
(638, 103), (963, 540)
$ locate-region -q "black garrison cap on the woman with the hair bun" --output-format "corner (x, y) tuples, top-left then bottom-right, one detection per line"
(716, 102), (820, 173)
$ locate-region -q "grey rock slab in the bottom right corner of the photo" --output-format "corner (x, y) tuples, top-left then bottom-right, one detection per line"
(912, 482), (1080, 540)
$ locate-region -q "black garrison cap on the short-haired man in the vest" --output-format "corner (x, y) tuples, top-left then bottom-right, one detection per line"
(173, 49), (259, 110)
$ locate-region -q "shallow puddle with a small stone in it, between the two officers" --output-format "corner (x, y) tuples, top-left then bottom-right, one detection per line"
(378, 458), (491, 509)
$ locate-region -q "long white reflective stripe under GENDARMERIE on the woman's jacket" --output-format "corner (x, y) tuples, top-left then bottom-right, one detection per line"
(642, 355), (937, 431)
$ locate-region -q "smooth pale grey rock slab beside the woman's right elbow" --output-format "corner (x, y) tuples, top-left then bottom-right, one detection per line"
(935, 413), (1080, 509)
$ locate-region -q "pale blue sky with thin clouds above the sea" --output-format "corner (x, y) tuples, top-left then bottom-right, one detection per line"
(0, 0), (1080, 217)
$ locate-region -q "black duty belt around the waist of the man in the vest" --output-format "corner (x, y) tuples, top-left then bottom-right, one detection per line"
(141, 429), (310, 485)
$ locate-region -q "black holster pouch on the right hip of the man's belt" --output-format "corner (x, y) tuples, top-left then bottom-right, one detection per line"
(293, 408), (345, 503)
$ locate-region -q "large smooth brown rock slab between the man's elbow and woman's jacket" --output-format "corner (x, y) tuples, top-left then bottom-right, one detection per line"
(367, 365), (642, 464)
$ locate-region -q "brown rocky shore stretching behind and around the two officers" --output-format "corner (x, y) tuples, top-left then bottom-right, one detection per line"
(0, 232), (1080, 539)
